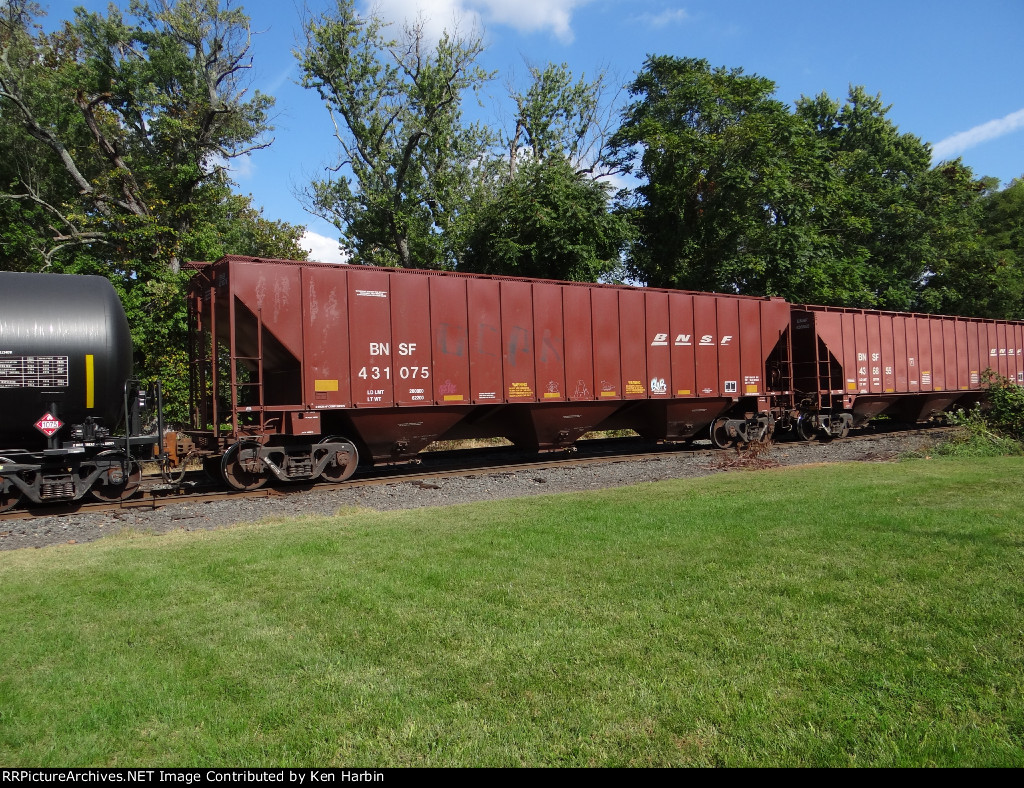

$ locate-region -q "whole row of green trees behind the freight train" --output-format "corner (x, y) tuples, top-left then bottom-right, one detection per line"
(0, 0), (1024, 418)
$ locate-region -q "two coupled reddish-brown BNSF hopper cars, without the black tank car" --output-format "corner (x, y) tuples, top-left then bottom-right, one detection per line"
(180, 257), (1024, 488)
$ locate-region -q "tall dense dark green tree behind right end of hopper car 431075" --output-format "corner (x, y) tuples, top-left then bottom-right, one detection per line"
(612, 55), (821, 294)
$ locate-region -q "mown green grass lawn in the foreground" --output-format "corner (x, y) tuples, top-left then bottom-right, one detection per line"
(0, 457), (1024, 767)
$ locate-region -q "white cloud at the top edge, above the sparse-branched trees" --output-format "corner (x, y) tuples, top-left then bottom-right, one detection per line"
(366, 0), (592, 43)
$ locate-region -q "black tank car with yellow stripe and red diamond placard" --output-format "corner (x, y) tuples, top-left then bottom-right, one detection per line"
(0, 272), (159, 512)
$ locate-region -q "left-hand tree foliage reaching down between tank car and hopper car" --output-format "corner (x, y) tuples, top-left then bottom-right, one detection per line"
(0, 0), (305, 423)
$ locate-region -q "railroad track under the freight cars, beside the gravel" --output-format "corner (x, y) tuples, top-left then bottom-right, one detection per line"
(0, 427), (949, 522)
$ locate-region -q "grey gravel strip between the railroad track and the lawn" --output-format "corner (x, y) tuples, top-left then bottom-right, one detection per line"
(0, 425), (939, 551)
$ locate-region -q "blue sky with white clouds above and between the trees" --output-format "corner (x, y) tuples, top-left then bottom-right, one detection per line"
(51, 0), (1024, 260)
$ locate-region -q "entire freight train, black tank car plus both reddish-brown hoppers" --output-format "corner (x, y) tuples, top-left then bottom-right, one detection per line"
(0, 257), (1024, 511)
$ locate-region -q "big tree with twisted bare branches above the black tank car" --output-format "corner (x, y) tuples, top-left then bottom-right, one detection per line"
(0, 0), (272, 272)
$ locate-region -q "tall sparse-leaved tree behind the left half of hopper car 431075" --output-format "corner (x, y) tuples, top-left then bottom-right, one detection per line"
(301, 0), (489, 268)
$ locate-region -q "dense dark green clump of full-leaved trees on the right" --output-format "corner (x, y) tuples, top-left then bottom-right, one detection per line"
(614, 56), (999, 316)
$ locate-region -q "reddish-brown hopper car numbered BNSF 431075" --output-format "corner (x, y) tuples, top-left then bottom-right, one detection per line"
(182, 257), (790, 486)
